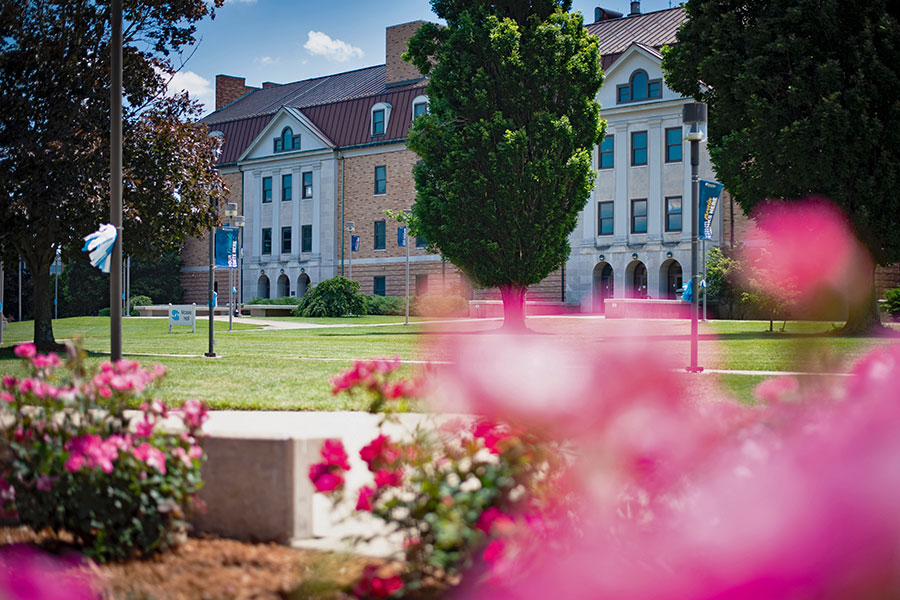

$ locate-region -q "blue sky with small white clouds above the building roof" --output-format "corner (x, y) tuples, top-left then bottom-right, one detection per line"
(170, 0), (679, 112)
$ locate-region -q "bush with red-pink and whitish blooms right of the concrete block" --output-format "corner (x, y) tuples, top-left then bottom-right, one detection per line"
(309, 359), (566, 598)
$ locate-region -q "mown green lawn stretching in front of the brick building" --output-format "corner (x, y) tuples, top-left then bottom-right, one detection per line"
(0, 317), (893, 410)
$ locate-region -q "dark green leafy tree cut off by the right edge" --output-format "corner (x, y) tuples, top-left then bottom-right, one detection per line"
(663, 0), (900, 333)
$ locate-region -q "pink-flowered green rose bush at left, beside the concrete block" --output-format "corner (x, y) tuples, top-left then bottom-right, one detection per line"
(0, 344), (206, 561)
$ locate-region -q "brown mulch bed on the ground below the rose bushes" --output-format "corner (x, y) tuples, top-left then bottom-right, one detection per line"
(0, 527), (372, 600)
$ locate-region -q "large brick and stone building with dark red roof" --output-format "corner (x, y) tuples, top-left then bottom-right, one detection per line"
(183, 3), (743, 310)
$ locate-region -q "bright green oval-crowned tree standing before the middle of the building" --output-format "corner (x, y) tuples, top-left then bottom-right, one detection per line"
(405, 0), (604, 329)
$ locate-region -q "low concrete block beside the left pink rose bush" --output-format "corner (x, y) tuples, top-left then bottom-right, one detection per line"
(194, 436), (324, 544)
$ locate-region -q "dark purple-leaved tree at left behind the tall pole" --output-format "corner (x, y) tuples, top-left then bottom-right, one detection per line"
(0, 0), (225, 348)
